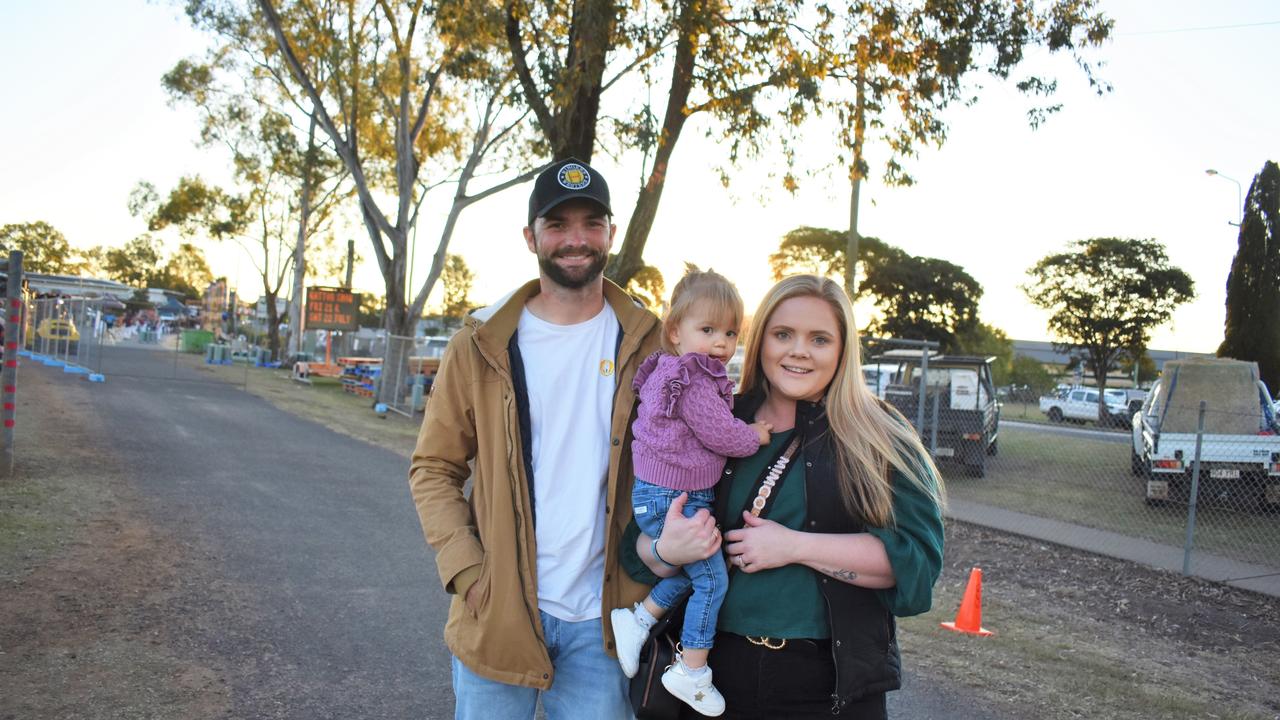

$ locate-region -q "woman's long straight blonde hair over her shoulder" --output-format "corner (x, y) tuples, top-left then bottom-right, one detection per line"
(741, 275), (946, 528)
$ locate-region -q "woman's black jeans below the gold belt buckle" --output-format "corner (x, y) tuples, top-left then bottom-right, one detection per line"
(681, 633), (888, 720)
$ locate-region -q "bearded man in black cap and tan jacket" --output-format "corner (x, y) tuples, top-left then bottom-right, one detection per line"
(410, 159), (659, 720)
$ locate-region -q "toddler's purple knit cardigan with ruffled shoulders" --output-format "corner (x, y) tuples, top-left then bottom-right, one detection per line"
(631, 351), (760, 491)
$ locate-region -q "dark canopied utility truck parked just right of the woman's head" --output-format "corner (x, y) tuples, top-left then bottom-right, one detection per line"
(873, 350), (1000, 478)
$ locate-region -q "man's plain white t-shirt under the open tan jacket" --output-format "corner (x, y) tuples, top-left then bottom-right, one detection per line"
(517, 302), (618, 623)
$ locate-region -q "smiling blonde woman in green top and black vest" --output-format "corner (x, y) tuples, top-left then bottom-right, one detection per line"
(632, 275), (943, 719)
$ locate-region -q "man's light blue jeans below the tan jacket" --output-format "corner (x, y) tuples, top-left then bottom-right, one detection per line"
(453, 612), (635, 720)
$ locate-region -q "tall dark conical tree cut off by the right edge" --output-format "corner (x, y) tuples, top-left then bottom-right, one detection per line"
(1217, 161), (1280, 393)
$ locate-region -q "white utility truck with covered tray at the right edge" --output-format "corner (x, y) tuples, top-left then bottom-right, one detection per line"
(1132, 357), (1280, 510)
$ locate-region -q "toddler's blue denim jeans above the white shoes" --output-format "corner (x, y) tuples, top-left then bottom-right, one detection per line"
(631, 478), (728, 650)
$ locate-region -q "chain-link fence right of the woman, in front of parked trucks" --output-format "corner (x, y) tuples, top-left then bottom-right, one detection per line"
(864, 341), (1280, 589)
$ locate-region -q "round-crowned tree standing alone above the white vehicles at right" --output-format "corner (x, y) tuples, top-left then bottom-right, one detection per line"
(1023, 237), (1196, 418)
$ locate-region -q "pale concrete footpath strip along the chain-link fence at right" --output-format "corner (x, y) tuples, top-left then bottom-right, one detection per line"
(947, 498), (1280, 597)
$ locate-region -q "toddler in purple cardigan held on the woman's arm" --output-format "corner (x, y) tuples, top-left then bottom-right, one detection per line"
(611, 270), (769, 716)
